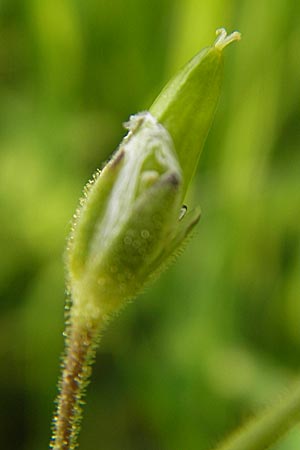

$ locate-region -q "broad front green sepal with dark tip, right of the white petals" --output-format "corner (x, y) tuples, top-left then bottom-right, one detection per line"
(91, 172), (181, 308)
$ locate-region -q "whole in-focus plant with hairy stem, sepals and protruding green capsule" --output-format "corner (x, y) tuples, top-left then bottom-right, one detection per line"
(50, 29), (300, 450)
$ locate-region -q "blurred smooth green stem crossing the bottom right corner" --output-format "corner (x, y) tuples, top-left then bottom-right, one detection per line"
(215, 382), (300, 450)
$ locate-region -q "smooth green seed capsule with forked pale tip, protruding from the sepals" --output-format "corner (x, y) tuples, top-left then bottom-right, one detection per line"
(150, 28), (241, 195)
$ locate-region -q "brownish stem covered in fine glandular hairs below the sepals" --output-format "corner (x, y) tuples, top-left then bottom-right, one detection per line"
(50, 325), (99, 450)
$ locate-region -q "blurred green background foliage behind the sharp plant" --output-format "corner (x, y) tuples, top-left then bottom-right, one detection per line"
(0, 0), (300, 450)
